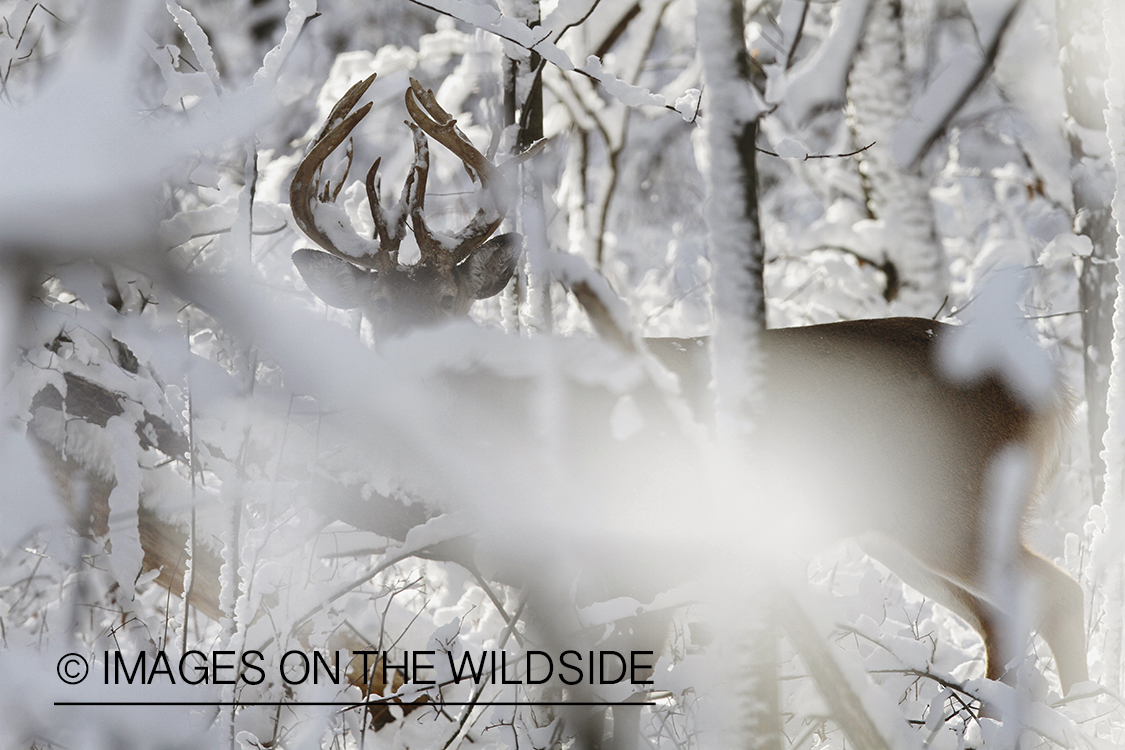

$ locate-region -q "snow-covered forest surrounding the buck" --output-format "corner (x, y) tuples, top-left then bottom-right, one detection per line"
(0, 0), (1125, 748)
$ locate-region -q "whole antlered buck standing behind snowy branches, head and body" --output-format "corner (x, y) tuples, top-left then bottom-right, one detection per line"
(290, 76), (1088, 706)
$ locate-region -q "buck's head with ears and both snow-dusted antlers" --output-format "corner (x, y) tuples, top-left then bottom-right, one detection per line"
(289, 75), (521, 341)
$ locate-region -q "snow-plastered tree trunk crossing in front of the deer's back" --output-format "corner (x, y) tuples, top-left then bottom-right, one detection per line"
(696, 0), (782, 750)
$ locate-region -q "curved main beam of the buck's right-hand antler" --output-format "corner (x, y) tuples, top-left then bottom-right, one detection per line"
(406, 79), (506, 264)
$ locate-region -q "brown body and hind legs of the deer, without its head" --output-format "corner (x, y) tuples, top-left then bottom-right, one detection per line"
(647, 318), (1088, 692)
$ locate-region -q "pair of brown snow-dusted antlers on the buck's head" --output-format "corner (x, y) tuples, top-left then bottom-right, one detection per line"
(289, 75), (504, 271)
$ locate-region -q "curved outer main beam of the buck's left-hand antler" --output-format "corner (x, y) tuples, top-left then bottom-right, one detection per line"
(289, 75), (383, 264)
